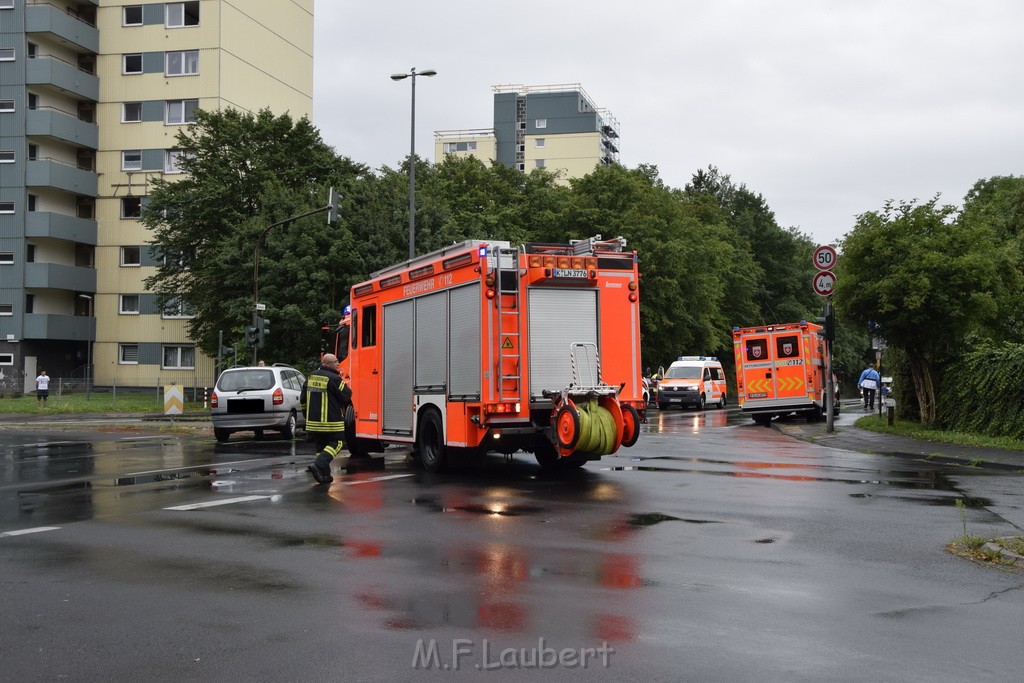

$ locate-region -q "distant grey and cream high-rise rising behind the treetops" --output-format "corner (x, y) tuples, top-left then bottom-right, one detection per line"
(434, 83), (618, 182)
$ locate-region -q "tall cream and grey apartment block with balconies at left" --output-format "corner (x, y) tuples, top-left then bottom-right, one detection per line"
(0, 0), (313, 391)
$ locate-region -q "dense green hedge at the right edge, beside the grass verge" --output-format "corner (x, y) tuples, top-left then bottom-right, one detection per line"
(939, 344), (1024, 438)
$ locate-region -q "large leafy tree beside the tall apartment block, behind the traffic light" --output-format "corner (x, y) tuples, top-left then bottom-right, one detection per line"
(142, 110), (366, 362)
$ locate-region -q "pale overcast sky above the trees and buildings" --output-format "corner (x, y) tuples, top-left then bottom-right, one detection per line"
(313, 0), (1024, 244)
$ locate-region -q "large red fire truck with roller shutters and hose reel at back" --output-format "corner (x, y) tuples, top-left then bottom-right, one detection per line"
(325, 236), (646, 471)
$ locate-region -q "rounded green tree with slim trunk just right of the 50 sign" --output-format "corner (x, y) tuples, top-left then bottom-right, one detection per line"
(835, 198), (1008, 425)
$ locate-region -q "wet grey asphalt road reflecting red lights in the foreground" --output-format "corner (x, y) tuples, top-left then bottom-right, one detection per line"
(0, 410), (1024, 681)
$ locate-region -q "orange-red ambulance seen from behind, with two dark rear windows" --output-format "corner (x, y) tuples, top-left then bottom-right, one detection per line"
(732, 322), (827, 424)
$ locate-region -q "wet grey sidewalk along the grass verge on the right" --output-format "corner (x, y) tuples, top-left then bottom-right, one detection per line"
(771, 402), (1024, 472)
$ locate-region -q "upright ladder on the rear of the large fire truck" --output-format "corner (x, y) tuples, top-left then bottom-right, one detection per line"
(495, 247), (522, 400)
